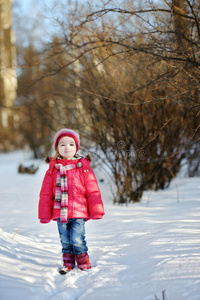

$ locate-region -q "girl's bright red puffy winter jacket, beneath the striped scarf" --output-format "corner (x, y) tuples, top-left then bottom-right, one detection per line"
(39, 158), (104, 223)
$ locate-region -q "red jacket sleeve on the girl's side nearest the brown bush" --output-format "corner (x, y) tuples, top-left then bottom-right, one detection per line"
(84, 168), (105, 219)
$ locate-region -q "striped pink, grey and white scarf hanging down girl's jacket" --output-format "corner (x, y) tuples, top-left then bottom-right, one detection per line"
(54, 162), (82, 223)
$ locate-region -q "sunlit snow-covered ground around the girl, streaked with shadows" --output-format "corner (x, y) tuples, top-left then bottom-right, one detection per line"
(0, 152), (200, 300)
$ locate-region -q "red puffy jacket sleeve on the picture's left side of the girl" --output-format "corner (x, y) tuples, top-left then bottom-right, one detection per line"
(38, 170), (54, 220)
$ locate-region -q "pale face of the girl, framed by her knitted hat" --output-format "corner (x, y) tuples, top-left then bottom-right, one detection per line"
(58, 136), (76, 159)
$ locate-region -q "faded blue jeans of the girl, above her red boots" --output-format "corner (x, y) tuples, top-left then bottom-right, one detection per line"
(57, 219), (88, 255)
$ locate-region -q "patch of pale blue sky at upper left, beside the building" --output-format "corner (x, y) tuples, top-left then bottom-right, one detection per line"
(13, 0), (68, 46)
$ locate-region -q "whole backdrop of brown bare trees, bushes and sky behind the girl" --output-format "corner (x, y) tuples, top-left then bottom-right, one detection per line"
(1, 0), (200, 204)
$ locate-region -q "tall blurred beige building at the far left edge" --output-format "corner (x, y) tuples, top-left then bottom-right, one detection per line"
(0, 0), (17, 150)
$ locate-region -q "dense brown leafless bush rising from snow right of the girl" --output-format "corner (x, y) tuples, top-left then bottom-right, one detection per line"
(76, 40), (199, 203)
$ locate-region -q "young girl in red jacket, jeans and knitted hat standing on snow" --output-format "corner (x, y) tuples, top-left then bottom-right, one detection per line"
(39, 128), (104, 274)
